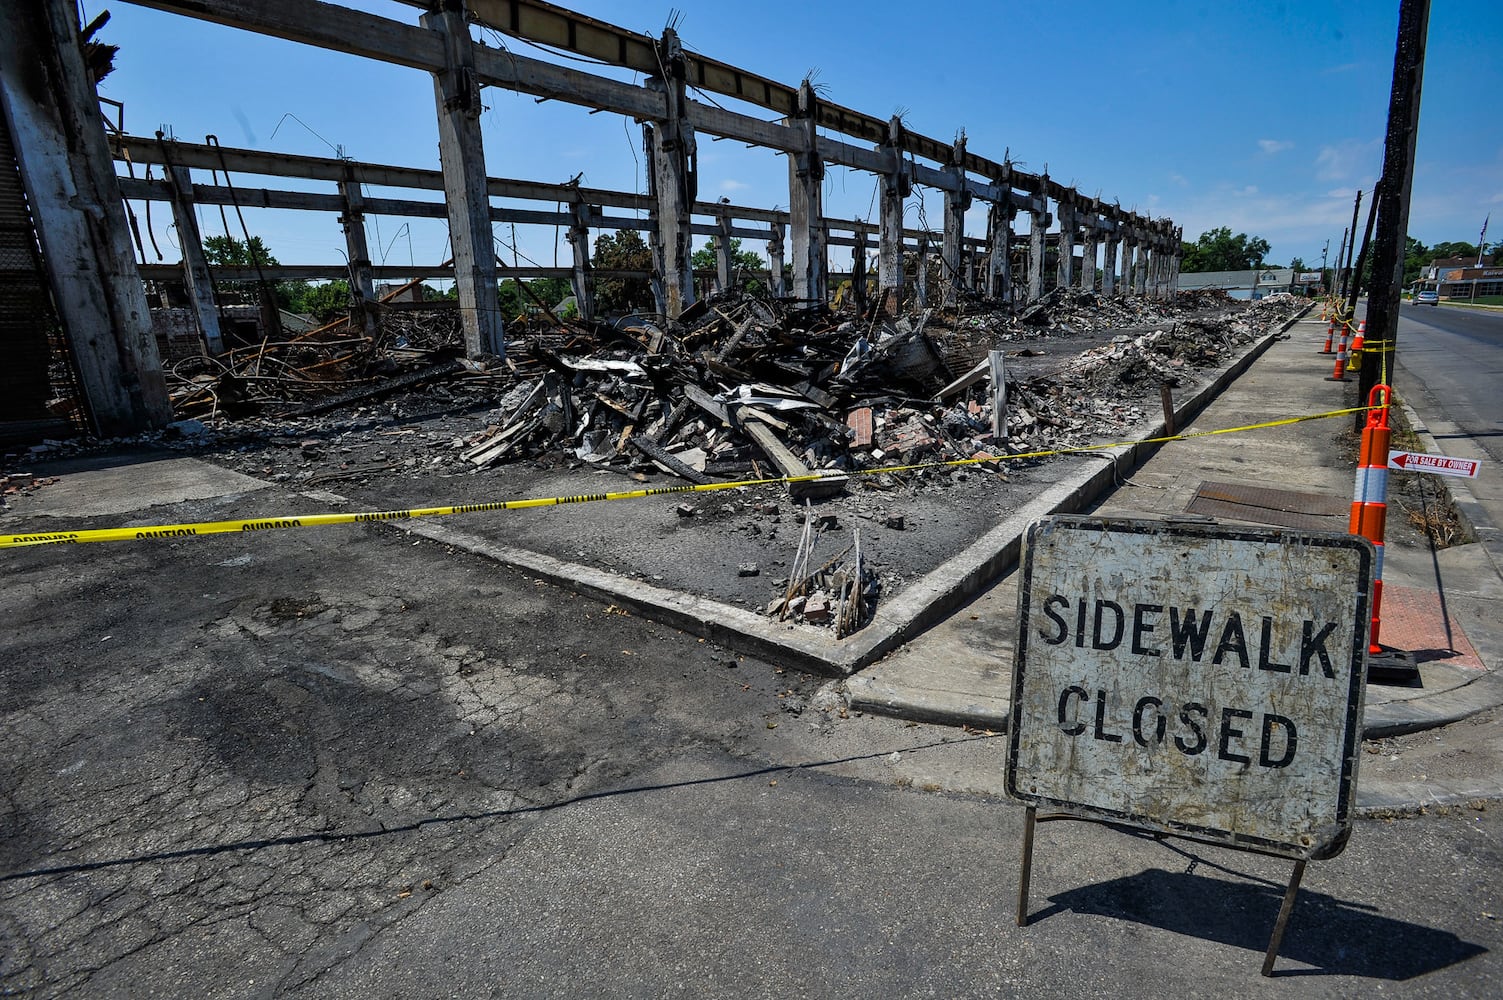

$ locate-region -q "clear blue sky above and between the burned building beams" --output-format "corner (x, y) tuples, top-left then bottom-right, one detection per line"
(83, 0), (1503, 273)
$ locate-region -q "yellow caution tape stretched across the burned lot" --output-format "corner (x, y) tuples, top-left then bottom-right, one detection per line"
(0, 406), (1381, 549)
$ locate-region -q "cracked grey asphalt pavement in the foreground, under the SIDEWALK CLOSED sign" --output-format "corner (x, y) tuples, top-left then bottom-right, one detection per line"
(0, 472), (1503, 997)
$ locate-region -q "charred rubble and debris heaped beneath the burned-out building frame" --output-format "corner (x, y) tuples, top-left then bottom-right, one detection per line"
(5, 289), (1302, 635)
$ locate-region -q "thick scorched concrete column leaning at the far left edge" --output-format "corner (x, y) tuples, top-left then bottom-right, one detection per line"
(0, 0), (173, 436)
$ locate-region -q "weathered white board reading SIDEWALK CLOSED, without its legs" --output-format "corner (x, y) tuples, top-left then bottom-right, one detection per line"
(1007, 517), (1375, 860)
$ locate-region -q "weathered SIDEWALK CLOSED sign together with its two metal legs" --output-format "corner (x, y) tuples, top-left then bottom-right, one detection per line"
(1006, 516), (1377, 976)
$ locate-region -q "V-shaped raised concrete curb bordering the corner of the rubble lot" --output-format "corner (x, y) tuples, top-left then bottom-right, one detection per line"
(389, 307), (1312, 679)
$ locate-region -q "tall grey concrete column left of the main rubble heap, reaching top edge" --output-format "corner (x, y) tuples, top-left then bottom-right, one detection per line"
(421, 0), (507, 358)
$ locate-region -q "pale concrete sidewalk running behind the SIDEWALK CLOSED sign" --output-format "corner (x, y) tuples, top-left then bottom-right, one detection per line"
(843, 316), (1503, 757)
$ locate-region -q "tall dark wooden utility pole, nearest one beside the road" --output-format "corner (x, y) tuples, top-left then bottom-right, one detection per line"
(1356, 0), (1429, 430)
